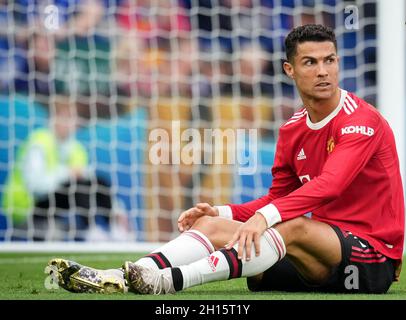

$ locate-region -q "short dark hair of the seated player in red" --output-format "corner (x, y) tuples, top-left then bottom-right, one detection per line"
(285, 24), (337, 62)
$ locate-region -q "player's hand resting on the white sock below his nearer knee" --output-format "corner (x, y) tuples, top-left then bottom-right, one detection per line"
(225, 213), (267, 261)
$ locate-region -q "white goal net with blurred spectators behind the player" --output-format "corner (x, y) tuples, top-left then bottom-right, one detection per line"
(0, 0), (377, 248)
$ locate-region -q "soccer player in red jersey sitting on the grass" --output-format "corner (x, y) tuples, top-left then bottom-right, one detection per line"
(46, 25), (405, 294)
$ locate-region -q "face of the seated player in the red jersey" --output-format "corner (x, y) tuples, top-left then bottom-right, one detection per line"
(284, 41), (339, 100)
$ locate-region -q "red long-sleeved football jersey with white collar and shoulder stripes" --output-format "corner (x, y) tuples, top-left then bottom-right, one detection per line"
(225, 90), (405, 259)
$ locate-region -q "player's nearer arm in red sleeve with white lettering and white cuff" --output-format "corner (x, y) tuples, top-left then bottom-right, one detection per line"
(257, 115), (385, 227)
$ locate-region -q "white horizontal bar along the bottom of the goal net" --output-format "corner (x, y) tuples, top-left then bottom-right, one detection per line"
(0, 242), (163, 253)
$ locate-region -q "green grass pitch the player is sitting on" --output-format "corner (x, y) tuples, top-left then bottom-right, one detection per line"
(0, 253), (406, 300)
